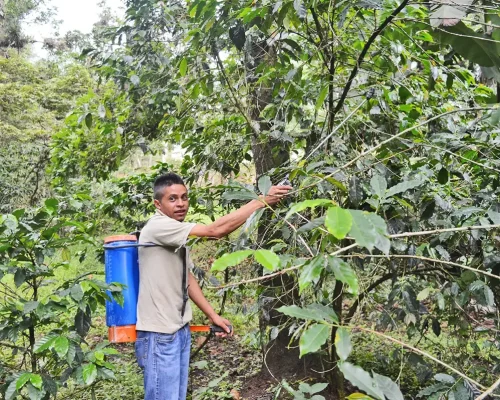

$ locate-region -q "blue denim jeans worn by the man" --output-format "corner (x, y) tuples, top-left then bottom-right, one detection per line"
(135, 325), (191, 400)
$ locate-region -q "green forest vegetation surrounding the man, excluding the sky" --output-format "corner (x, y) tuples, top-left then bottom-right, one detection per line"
(0, 0), (500, 400)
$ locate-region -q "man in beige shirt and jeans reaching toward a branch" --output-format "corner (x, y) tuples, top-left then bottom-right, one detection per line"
(135, 173), (292, 400)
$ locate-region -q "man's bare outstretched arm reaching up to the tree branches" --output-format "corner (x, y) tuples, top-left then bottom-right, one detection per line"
(189, 186), (292, 238)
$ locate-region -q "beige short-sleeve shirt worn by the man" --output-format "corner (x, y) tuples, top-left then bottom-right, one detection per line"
(136, 211), (196, 333)
